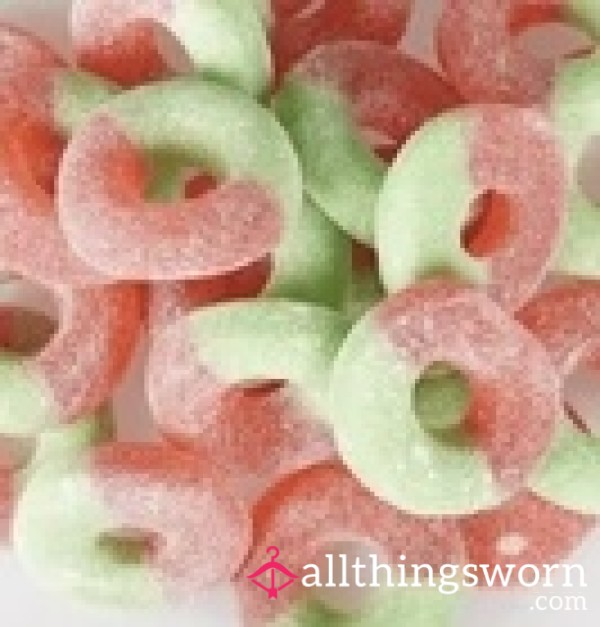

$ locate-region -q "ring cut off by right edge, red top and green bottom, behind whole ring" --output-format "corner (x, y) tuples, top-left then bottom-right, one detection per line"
(518, 279), (600, 515)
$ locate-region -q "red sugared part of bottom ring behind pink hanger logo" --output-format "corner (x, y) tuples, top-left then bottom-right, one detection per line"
(238, 463), (463, 624)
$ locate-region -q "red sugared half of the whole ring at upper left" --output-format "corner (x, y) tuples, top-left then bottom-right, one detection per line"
(59, 115), (280, 281)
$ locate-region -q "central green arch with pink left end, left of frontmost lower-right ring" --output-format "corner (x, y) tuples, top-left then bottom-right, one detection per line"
(147, 299), (348, 436)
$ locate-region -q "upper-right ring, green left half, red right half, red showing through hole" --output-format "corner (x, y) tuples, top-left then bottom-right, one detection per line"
(376, 105), (565, 310)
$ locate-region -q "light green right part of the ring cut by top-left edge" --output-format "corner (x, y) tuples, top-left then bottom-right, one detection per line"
(170, 0), (271, 96)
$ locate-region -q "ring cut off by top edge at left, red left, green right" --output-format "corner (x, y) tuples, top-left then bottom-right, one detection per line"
(71, 0), (271, 95)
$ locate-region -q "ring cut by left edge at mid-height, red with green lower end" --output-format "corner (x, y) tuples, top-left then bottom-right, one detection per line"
(0, 285), (143, 436)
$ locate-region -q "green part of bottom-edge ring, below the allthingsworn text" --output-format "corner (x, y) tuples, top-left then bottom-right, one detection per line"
(268, 588), (456, 627)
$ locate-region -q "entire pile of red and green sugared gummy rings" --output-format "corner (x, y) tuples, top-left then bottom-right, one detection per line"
(0, 0), (600, 627)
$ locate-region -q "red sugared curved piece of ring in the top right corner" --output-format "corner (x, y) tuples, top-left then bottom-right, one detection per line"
(437, 0), (555, 104)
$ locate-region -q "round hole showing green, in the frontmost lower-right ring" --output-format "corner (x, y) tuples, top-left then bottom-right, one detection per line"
(413, 362), (471, 443)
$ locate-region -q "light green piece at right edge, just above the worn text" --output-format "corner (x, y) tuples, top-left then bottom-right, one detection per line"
(529, 418), (600, 515)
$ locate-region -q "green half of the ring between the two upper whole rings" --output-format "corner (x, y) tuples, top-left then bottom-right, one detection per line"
(272, 75), (385, 246)
